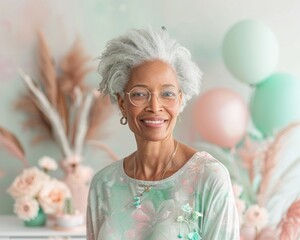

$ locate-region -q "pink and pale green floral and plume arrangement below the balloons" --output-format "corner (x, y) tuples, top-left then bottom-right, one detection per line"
(196, 123), (300, 240)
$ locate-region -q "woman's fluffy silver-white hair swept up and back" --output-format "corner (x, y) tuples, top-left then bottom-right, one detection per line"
(98, 27), (202, 112)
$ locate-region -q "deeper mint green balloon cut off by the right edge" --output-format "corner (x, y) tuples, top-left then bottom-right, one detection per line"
(250, 73), (300, 136)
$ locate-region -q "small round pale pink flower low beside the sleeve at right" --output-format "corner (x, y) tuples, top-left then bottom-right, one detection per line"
(244, 205), (268, 231)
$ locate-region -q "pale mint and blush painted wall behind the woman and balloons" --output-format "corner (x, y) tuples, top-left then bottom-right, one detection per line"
(0, 0), (300, 214)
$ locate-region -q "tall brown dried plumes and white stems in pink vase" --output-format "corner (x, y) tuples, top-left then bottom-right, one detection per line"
(12, 33), (118, 213)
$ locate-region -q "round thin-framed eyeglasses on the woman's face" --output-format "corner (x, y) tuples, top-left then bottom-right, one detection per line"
(125, 86), (181, 107)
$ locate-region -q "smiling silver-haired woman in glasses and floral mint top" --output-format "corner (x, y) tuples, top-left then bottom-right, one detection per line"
(87, 29), (239, 240)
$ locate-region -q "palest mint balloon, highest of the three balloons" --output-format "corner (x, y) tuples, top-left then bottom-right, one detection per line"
(222, 20), (279, 84)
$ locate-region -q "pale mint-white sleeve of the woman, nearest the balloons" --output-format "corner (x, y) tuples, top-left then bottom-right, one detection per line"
(199, 160), (240, 240)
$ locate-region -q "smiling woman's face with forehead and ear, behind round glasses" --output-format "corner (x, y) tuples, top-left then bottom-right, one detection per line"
(118, 60), (182, 141)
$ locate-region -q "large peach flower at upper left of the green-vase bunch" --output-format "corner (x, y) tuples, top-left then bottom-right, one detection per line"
(8, 167), (49, 198)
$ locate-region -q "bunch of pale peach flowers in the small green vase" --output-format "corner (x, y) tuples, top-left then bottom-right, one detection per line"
(8, 156), (71, 221)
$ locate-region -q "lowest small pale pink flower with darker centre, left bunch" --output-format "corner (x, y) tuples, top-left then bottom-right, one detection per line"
(14, 197), (39, 220)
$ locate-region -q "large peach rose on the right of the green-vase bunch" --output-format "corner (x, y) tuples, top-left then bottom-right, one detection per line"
(38, 179), (71, 214)
